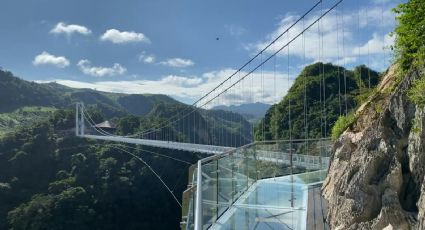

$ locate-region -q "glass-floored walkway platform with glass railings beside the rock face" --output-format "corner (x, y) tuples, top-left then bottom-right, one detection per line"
(181, 139), (331, 229)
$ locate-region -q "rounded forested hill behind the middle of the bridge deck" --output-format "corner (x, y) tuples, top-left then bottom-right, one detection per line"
(142, 104), (252, 147)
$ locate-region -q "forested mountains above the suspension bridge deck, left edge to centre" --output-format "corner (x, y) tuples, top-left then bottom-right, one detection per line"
(0, 71), (252, 146)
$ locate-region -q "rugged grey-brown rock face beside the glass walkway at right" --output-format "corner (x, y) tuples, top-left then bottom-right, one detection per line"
(322, 66), (425, 229)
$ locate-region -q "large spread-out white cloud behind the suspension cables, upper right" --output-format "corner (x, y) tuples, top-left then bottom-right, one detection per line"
(245, 5), (395, 68)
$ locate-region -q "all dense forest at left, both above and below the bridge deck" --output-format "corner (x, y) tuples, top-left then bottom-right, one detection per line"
(0, 71), (251, 230)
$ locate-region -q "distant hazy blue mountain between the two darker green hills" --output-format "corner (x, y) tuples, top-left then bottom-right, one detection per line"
(213, 102), (270, 122)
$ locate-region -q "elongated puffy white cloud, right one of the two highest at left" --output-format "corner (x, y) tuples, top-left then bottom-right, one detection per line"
(100, 29), (150, 44)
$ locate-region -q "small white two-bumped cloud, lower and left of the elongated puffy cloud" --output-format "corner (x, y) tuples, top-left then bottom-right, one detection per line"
(77, 59), (127, 77)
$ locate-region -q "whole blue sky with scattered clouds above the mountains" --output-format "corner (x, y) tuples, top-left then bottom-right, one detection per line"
(0, 0), (398, 104)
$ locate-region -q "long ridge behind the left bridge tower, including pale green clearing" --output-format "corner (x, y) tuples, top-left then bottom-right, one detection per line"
(0, 70), (177, 136)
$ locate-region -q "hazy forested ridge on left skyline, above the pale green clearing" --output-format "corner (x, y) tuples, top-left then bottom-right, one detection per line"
(0, 70), (180, 117)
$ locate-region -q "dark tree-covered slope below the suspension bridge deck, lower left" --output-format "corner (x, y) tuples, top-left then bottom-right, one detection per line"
(0, 118), (198, 230)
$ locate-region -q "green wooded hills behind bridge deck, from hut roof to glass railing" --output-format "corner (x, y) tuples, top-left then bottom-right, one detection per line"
(112, 103), (252, 146)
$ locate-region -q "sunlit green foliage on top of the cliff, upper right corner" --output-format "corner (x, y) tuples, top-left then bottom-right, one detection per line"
(394, 0), (425, 70)
